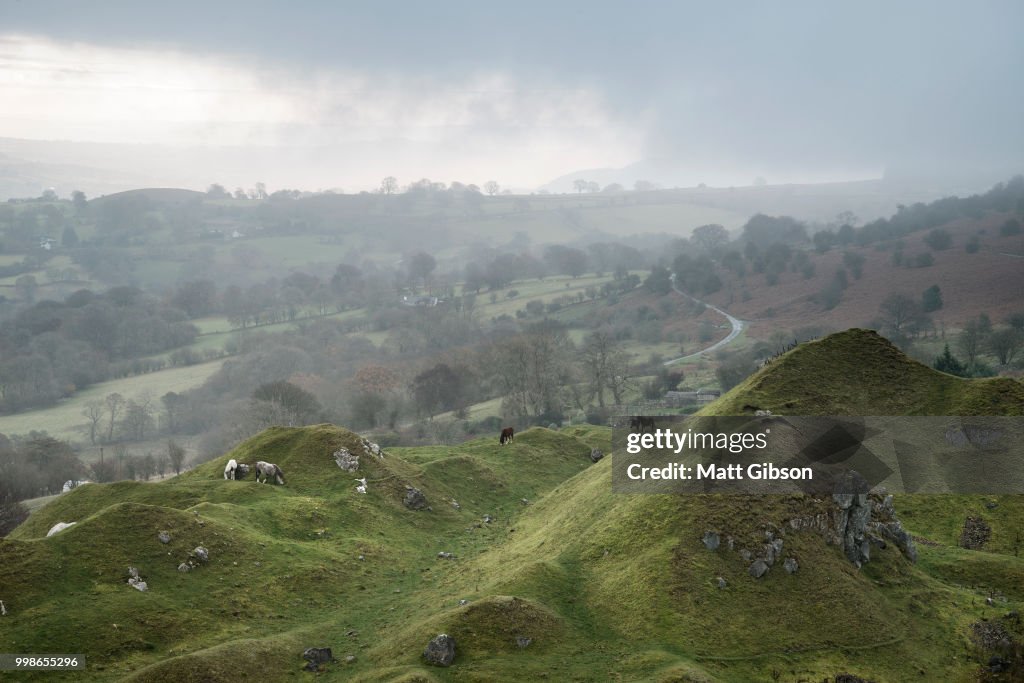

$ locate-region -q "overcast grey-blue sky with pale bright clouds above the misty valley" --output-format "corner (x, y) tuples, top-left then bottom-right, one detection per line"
(0, 0), (1024, 190)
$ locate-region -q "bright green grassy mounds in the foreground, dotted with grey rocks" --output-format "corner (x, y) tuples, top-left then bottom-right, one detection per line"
(0, 330), (1024, 683)
